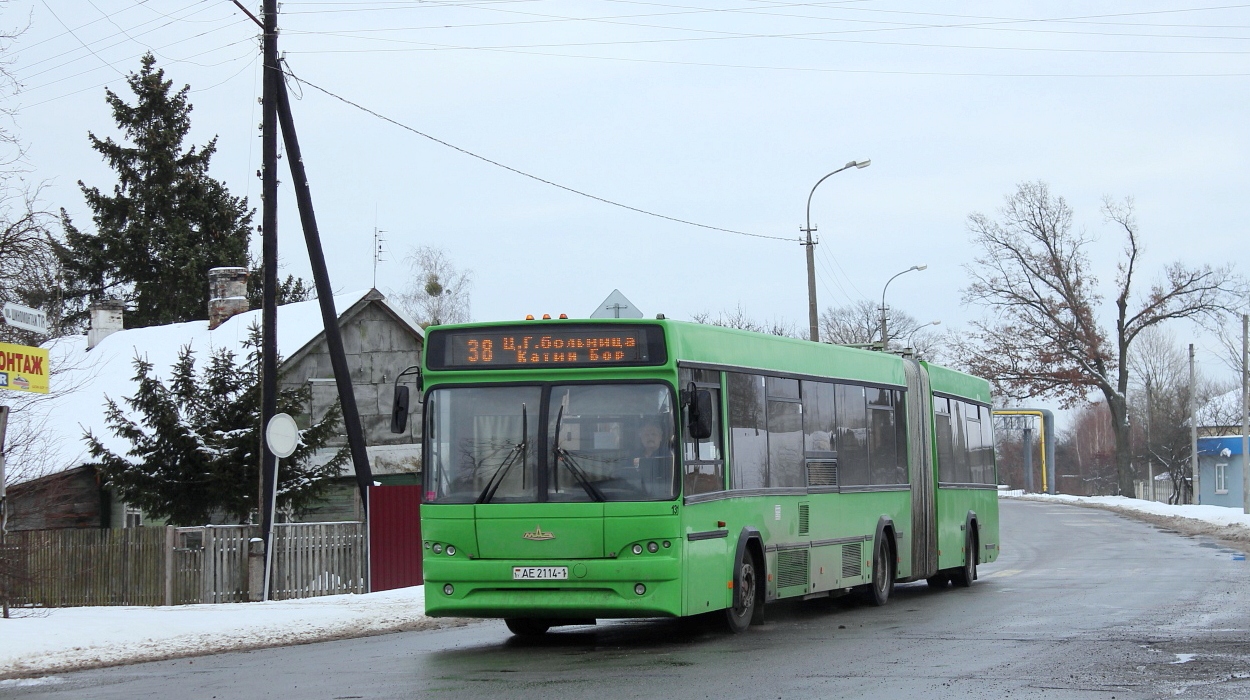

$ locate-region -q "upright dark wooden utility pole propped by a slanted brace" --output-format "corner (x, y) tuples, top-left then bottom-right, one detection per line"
(256, 0), (280, 585)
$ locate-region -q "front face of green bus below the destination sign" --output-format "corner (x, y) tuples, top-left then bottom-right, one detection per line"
(423, 379), (681, 625)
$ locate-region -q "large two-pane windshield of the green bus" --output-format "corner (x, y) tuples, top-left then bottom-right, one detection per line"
(425, 384), (678, 504)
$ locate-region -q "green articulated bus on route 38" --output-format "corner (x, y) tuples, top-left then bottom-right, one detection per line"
(393, 319), (999, 635)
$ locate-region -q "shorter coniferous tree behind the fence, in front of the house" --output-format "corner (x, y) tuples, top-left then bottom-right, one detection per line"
(86, 328), (348, 525)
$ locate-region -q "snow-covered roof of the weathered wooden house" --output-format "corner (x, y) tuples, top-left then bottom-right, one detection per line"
(10, 290), (424, 481)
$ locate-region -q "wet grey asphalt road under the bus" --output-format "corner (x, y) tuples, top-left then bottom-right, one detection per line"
(0, 501), (1250, 700)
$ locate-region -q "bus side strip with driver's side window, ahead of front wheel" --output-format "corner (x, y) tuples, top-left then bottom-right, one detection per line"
(680, 369), (738, 615)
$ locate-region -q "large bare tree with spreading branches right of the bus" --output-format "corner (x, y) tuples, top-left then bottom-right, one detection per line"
(958, 183), (1235, 495)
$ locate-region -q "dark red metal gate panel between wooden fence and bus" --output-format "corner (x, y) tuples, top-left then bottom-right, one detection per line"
(369, 485), (424, 591)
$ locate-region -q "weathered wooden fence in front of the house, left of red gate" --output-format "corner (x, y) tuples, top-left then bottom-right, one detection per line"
(0, 523), (368, 608)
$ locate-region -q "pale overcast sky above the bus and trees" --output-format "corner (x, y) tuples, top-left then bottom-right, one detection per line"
(3, 0), (1250, 405)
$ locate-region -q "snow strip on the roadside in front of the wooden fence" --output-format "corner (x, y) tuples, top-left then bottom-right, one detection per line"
(0, 586), (431, 689)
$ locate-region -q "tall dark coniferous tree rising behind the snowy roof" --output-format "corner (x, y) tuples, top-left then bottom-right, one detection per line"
(58, 54), (254, 328)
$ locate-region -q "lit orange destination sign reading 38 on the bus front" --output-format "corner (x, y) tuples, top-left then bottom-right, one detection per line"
(429, 324), (665, 369)
